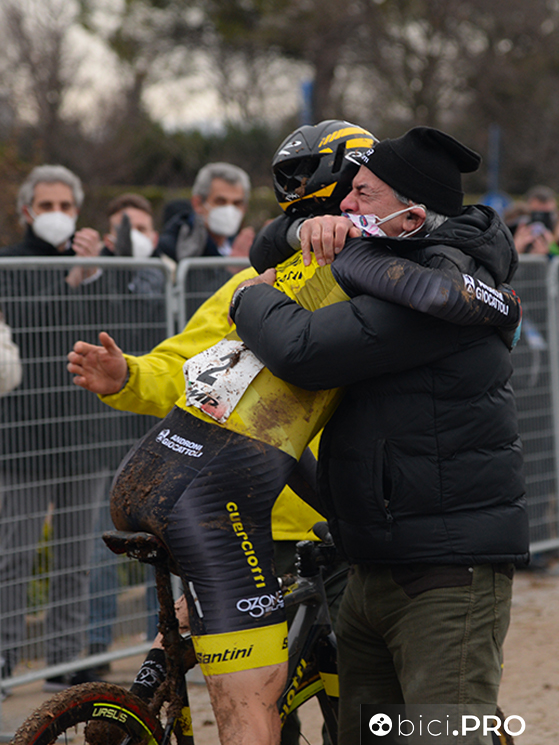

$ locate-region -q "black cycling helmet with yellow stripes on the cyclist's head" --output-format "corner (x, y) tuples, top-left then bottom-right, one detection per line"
(272, 119), (377, 215)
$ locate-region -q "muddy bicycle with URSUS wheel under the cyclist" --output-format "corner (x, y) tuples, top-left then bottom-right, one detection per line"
(12, 523), (514, 745)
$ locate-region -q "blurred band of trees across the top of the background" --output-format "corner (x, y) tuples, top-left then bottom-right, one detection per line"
(0, 0), (559, 199)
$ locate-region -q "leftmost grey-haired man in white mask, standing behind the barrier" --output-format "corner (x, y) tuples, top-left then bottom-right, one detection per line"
(0, 165), (110, 690)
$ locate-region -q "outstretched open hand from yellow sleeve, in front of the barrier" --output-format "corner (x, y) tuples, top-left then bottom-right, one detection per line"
(67, 331), (128, 396)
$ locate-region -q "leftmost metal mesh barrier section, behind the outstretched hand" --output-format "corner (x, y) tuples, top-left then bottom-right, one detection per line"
(0, 257), (174, 720)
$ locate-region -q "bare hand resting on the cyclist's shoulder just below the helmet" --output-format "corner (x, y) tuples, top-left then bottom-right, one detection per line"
(299, 215), (361, 266)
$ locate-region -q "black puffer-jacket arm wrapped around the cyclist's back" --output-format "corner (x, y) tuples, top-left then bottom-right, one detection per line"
(235, 284), (462, 390)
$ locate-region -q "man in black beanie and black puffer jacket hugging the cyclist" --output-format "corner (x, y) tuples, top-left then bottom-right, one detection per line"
(235, 127), (528, 745)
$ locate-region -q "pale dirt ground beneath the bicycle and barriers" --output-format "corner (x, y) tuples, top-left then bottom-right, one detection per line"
(0, 564), (559, 745)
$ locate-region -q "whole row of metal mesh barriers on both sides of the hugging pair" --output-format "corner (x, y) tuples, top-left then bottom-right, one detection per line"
(0, 250), (559, 728)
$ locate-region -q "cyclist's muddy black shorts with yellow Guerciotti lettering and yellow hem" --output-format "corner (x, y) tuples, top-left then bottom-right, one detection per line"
(111, 408), (296, 675)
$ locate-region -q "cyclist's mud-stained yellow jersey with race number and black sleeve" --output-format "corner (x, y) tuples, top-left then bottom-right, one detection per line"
(179, 241), (520, 458)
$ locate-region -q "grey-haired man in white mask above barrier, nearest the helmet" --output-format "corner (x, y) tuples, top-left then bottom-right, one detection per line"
(159, 163), (254, 261)
